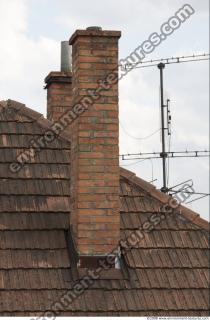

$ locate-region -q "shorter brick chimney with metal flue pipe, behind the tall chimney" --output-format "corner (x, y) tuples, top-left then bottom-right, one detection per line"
(45, 41), (72, 121)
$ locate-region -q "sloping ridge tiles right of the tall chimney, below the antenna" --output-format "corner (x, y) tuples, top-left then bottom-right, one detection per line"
(120, 168), (210, 231)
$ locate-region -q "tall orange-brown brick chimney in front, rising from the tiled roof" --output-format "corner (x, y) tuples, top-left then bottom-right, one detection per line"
(69, 27), (121, 267)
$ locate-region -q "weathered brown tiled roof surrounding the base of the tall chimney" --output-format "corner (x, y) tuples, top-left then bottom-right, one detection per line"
(0, 102), (209, 316)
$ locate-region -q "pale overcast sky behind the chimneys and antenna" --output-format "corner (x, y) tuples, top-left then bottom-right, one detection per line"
(0, 0), (209, 219)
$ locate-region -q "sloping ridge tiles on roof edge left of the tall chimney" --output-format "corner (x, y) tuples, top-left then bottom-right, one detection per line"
(6, 99), (70, 142)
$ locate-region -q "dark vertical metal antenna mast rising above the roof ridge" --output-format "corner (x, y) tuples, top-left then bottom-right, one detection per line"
(158, 63), (168, 193)
